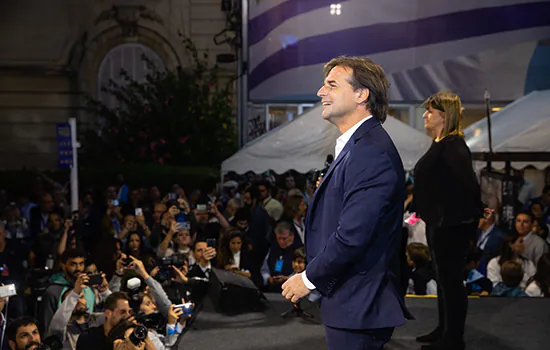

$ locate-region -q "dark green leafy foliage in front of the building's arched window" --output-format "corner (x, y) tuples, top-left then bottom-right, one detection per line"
(82, 38), (237, 166)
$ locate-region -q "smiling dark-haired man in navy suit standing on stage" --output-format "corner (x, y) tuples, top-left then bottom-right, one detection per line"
(283, 57), (411, 350)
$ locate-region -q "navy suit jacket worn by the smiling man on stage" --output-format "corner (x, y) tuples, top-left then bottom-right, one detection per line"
(305, 118), (411, 329)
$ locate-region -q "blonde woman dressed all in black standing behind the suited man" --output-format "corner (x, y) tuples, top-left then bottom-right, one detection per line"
(414, 92), (483, 350)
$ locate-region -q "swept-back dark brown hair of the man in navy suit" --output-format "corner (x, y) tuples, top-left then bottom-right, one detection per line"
(324, 56), (389, 123)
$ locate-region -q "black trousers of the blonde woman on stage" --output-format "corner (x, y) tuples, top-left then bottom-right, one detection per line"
(426, 225), (476, 341)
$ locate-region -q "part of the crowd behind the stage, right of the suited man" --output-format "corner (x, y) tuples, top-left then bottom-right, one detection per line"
(405, 182), (550, 297)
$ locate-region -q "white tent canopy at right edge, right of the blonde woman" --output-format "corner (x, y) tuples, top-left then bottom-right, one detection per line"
(464, 90), (550, 169)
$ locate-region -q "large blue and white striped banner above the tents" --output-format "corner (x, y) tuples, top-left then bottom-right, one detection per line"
(249, 0), (550, 102)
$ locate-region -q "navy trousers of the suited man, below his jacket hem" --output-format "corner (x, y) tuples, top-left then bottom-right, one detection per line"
(325, 326), (393, 350)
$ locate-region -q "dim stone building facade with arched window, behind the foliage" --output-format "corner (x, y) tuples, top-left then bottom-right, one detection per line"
(0, 0), (236, 169)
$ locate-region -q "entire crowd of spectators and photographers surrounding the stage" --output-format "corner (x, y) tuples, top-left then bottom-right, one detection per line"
(0, 168), (550, 349)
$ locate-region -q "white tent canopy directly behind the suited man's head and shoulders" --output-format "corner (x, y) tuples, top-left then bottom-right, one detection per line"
(222, 105), (431, 174)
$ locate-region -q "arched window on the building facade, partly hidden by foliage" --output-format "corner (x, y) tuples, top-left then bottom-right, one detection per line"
(97, 43), (165, 108)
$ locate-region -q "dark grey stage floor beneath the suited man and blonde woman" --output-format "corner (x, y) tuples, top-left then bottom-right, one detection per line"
(178, 294), (550, 350)
